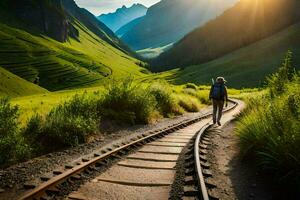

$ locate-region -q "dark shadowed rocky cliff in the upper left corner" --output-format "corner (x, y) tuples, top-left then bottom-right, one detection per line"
(0, 0), (78, 42)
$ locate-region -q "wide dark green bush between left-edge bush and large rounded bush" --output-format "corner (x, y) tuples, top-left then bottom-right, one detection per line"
(23, 94), (100, 154)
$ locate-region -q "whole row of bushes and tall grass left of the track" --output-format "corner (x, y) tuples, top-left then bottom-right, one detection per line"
(0, 78), (207, 164)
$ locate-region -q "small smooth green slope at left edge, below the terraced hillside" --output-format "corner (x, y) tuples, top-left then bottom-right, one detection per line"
(0, 67), (48, 97)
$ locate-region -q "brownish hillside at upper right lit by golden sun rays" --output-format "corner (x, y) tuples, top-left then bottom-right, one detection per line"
(154, 0), (300, 71)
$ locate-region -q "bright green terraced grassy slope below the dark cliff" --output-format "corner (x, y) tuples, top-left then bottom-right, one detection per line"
(0, 21), (144, 91)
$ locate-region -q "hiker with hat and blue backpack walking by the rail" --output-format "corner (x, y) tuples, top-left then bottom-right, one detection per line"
(209, 77), (228, 126)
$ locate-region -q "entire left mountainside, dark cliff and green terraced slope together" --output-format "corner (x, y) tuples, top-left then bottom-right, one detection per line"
(0, 0), (143, 91)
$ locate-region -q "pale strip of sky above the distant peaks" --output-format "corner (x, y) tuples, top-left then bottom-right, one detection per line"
(75, 0), (160, 16)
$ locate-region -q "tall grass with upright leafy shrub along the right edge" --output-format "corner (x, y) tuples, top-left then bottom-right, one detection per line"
(237, 53), (300, 188)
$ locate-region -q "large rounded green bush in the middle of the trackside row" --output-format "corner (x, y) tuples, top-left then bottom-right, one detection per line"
(102, 79), (157, 124)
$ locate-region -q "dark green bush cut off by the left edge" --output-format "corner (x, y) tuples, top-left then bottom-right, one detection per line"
(0, 98), (28, 165)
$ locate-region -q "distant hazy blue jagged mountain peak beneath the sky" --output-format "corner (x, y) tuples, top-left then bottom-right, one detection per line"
(98, 4), (147, 32)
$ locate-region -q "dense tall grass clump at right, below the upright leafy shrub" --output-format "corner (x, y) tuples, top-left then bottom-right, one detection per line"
(238, 88), (300, 184)
